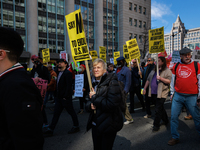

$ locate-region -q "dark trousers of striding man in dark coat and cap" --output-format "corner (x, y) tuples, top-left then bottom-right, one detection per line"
(49, 98), (79, 130)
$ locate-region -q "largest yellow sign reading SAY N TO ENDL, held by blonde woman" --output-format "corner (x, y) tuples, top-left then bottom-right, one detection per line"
(65, 9), (90, 62)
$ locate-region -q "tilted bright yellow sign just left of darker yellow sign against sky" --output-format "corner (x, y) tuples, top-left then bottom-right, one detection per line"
(126, 38), (140, 60)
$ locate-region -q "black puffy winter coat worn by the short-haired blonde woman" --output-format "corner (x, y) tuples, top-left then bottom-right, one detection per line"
(86, 74), (123, 134)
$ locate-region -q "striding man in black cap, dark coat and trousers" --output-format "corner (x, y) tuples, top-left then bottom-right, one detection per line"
(44, 59), (80, 136)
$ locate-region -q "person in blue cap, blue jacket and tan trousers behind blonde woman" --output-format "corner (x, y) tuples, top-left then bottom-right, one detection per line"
(116, 56), (133, 124)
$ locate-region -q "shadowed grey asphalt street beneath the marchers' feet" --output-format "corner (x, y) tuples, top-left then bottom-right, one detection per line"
(44, 99), (200, 150)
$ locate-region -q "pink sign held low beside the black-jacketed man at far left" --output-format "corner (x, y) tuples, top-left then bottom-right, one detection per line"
(32, 78), (48, 100)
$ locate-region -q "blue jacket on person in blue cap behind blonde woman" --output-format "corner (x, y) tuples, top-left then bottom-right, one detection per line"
(115, 66), (131, 93)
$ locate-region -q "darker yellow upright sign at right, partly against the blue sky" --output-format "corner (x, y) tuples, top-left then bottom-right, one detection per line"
(149, 27), (165, 54)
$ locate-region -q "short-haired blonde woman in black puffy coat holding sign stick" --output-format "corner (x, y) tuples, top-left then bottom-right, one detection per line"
(86, 59), (123, 150)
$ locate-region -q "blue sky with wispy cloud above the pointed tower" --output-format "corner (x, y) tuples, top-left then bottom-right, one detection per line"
(151, 0), (200, 34)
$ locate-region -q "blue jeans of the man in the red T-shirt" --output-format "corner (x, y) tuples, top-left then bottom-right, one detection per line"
(171, 92), (200, 139)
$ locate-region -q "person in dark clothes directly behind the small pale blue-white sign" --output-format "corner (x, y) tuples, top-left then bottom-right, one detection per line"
(78, 64), (89, 114)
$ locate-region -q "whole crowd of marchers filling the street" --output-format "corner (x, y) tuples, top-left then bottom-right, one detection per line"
(0, 27), (200, 150)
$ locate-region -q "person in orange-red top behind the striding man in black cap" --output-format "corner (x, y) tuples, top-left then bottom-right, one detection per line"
(44, 64), (57, 106)
